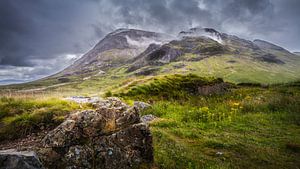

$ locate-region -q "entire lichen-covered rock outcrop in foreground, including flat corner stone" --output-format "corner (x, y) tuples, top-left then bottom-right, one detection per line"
(0, 98), (153, 169)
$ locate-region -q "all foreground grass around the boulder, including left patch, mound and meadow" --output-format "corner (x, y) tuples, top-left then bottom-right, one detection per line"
(0, 74), (300, 169)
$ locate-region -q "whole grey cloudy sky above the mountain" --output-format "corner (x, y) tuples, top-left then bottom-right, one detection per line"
(0, 0), (300, 84)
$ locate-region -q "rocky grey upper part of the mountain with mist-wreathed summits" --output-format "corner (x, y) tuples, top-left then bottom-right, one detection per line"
(56, 28), (297, 80)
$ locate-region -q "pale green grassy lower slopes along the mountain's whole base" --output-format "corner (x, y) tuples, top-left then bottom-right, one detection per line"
(0, 53), (300, 95)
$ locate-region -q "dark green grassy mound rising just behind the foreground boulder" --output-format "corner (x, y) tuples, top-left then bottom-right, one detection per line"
(116, 74), (223, 100)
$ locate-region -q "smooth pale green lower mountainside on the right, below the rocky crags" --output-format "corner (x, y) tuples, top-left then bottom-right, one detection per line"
(161, 55), (300, 84)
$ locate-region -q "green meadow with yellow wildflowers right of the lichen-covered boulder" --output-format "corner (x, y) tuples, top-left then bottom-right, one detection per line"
(120, 75), (300, 168)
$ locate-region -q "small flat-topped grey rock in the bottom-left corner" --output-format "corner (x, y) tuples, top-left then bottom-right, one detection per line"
(0, 149), (44, 169)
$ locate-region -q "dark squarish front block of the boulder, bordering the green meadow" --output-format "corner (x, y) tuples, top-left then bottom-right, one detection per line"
(95, 123), (153, 169)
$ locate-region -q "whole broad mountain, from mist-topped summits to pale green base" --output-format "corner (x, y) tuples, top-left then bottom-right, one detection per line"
(5, 27), (300, 92)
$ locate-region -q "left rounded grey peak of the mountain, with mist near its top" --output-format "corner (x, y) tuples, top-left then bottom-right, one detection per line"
(57, 29), (172, 75)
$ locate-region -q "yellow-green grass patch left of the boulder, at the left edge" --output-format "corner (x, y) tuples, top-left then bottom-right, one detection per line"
(0, 97), (89, 141)
